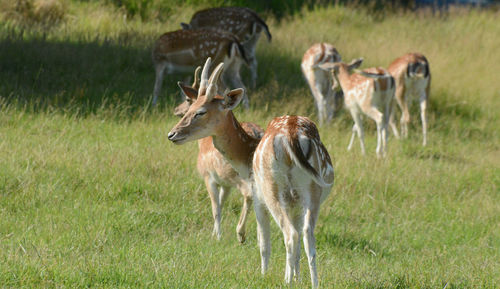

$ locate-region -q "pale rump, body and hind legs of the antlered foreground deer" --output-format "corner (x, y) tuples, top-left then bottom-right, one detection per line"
(253, 116), (334, 288)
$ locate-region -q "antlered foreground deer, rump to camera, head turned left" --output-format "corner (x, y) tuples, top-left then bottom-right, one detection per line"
(168, 59), (334, 287)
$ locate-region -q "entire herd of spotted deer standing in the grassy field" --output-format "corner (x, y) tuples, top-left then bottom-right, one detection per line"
(153, 7), (431, 288)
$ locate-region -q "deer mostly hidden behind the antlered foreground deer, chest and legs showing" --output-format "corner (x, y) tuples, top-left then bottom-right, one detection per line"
(174, 67), (264, 243)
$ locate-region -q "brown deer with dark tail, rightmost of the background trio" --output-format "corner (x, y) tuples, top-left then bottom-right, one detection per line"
(388, 53), (431, 146)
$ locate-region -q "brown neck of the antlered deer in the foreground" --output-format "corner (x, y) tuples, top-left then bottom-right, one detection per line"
(212, 111), (259, 179)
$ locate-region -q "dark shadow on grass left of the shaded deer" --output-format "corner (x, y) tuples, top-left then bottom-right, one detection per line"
(0, 33), (193, 113)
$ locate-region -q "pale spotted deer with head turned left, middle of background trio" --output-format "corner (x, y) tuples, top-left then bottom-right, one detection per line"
(320, 58), (397, 157)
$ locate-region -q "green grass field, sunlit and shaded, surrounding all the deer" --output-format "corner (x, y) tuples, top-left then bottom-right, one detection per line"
(0, 1), (500, 288)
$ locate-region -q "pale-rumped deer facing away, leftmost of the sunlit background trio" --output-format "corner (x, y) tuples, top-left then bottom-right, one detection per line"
(301, 43), (343, 125)
